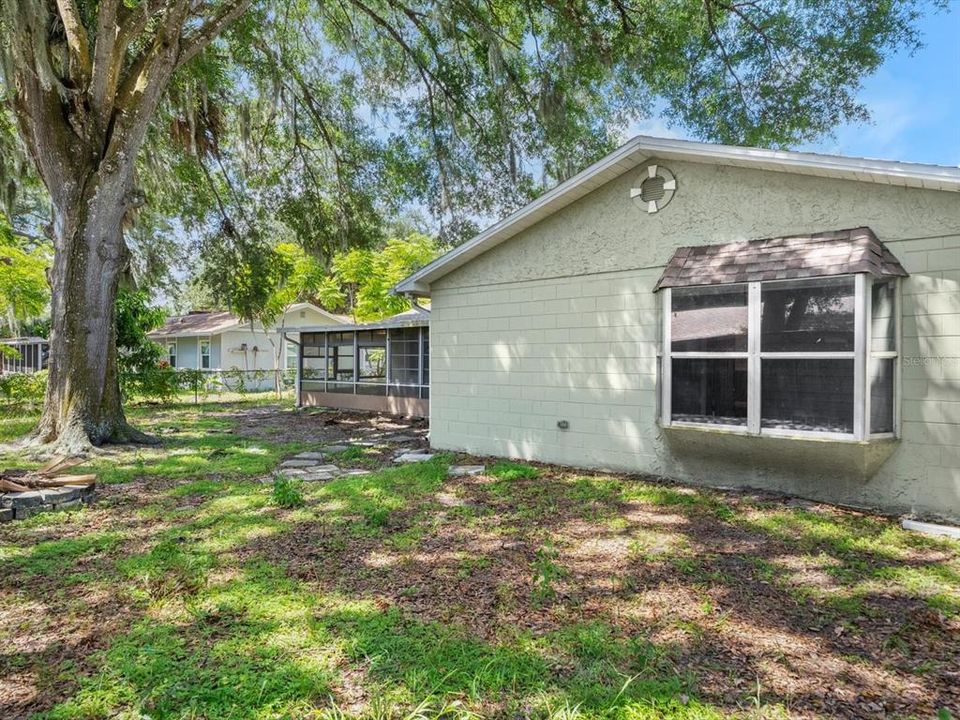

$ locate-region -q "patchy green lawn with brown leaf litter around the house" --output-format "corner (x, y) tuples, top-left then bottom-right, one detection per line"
(0, 401), (960, 720)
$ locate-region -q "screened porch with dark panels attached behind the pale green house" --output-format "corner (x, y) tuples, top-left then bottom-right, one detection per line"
(297, 306), (430, 417)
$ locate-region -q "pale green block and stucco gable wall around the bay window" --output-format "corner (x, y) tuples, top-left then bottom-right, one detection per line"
(430, 161), (960, 520)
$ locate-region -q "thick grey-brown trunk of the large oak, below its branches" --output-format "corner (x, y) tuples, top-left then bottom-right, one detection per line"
(34, 169), (147, 453)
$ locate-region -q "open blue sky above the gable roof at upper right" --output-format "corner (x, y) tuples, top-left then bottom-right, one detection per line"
(630, 0), (960, 166)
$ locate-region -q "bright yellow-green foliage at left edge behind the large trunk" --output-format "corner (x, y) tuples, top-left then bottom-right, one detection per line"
(0, 211), (53, 334)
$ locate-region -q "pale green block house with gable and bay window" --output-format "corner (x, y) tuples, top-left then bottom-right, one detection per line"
(396, 137), (960, 519)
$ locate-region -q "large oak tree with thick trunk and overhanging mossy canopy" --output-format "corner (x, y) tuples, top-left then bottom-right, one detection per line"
(0, 0), (942, 450)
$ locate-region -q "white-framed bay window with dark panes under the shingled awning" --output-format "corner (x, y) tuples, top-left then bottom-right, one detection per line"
(661, 273), (899, 439)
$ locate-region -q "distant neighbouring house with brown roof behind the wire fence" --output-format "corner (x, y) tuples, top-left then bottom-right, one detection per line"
(148, 303), (349, 387)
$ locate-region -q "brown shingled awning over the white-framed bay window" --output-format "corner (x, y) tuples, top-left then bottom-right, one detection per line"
(654, 227), (908, 292)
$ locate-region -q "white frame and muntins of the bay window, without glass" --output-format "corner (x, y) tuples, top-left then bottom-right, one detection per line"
(659, 273), (903, 442)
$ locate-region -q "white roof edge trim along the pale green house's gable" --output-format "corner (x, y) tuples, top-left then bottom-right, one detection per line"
(394, 135), (960, 296)
